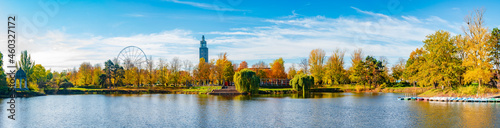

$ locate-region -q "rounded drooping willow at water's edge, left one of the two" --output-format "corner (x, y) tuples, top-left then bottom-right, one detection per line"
(233, 69), (260, 94)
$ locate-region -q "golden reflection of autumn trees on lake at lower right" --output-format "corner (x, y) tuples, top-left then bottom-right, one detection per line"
(408, 102), (496, 127)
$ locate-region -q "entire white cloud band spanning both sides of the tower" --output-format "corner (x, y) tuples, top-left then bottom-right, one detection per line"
(0, 7), (458, 71)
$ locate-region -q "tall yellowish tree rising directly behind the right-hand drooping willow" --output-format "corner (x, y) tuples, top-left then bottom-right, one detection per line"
(309, 49), (325, 85)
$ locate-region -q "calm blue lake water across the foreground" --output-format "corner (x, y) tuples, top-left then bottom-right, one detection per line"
(0, 93), (500, 128)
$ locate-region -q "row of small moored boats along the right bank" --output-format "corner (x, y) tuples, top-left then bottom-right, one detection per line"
(398, 97), (500, 102)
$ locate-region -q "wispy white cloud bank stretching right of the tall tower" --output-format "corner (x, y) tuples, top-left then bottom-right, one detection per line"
(212, 7), (459, 68)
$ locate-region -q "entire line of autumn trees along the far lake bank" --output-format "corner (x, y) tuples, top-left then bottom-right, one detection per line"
(0, 9), (500, 89)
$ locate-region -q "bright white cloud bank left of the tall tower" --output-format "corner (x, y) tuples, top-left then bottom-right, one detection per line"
(2, 29), (198, 71)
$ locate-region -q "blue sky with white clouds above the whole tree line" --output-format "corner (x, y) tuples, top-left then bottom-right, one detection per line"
(0, 0), (500, 71)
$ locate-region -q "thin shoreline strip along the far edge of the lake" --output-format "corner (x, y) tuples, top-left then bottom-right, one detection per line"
(4, 86), (500, 98)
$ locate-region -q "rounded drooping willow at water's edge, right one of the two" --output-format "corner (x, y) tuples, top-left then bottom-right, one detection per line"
(290, 74), (314, 91)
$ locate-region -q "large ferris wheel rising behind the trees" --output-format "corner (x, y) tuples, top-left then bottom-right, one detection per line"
(116, 46), (148, 69)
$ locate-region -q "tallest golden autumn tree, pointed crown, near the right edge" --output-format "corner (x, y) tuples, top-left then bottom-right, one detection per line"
(462, 9), (492, 87)
